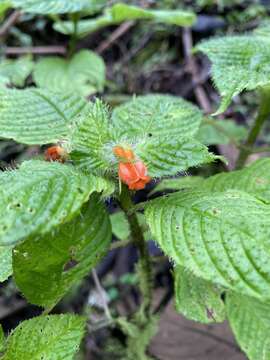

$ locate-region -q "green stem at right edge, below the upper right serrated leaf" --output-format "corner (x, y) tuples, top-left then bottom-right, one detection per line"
(236, 88), (270, 169)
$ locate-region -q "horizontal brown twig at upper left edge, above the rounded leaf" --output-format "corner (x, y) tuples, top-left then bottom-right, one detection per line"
(3, 46), (67, 55)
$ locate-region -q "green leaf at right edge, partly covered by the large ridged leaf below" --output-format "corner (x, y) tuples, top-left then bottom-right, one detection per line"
(200, 158), (270, 204)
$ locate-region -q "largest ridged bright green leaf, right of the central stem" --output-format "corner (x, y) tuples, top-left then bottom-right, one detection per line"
(146, 190), (270, 300)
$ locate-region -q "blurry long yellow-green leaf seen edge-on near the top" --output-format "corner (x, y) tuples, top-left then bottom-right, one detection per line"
(54, 3), (196, 38)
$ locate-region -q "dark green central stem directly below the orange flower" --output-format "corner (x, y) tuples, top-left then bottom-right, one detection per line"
(120, 186), (153, 318)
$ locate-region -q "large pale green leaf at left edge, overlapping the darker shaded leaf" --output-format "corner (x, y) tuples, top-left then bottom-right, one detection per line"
(0, 161), (108, 245)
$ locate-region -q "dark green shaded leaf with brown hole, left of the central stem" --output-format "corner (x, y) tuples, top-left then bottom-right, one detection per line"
(13, 194), (112, 308)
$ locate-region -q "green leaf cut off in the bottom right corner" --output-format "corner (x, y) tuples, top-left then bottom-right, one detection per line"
(226, 294), (270, 360)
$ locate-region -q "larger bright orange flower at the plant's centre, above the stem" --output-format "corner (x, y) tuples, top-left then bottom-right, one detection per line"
(118, 161), (151, 190)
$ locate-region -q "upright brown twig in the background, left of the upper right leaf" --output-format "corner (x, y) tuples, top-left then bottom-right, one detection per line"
(183, 28), (212, 114)
